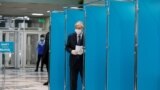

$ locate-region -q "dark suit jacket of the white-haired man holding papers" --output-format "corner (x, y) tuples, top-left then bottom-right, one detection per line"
(66, 33), (84, 66)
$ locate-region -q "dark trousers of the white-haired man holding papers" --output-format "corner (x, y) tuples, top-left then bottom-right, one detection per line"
(70, 57), (83, 90)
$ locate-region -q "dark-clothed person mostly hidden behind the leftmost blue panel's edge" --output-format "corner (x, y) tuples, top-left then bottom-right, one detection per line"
(42, 32), (49, 85)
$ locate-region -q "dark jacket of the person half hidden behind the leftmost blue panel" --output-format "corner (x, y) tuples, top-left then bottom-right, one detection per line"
(42, 32), (49, 64)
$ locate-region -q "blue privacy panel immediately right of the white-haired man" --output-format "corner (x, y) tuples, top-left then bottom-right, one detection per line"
(85, 6), (107, 90)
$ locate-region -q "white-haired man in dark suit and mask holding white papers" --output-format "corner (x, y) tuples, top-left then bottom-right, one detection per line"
(66, 21), (84, 90)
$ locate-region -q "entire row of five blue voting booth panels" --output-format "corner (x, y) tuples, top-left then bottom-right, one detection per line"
(50, 0), (160, 90)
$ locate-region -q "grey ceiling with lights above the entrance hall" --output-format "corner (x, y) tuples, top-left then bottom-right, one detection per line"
(0, 0), (82, 17)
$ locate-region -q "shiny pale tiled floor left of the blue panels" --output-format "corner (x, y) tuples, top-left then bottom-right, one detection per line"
(0, 68), (48, 90)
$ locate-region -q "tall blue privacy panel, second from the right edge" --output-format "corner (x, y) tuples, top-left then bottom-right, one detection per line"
(108, 2), (135, 90)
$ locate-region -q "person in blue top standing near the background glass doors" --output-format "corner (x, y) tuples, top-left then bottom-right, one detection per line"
(35, 35), (45, 72)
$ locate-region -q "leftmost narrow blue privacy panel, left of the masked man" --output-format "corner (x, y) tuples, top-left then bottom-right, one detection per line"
(50, 12), (65, 90)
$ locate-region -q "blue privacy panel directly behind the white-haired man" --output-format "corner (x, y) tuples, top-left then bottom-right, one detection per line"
(65, 9), (84, 90)
